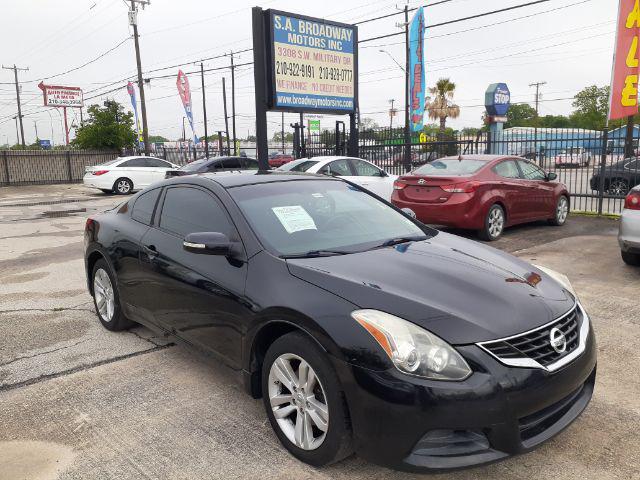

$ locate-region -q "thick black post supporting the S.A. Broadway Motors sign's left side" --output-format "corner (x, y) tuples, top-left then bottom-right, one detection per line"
(251, 7), (269, 170)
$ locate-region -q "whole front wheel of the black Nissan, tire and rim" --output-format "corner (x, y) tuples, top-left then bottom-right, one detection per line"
(262, 332), (353, 467)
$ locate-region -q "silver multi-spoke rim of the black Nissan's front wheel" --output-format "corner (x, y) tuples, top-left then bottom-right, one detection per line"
(269, 353), (329, 450)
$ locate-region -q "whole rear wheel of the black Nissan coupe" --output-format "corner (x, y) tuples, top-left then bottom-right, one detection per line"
(91, 258), (135, 332)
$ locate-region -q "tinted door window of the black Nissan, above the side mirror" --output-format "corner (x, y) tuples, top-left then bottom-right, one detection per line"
(160, 187), (232, 237)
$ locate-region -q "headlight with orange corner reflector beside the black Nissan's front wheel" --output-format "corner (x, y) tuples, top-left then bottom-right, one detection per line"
(351, 310), (471, 380)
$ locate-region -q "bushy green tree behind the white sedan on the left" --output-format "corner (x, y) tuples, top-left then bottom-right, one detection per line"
(73, 100), (136, 150)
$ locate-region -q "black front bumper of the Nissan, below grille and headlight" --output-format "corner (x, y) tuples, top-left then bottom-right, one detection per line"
(335, 318), (596, 471)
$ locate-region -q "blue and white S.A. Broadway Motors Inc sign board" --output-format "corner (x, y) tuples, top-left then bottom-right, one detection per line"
(266, 10), (358, 113)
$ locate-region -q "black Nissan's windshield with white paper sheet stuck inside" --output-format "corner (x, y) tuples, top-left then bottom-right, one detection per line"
(228, 180), (437, 256)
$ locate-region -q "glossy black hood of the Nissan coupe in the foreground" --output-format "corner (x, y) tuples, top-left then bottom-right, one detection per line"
(287, 232), (575, 345)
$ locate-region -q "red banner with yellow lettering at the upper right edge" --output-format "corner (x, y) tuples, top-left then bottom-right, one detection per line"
(609, 0), (640, 120)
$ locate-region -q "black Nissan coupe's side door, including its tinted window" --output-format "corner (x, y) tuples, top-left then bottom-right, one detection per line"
(140, 185), (250, 368)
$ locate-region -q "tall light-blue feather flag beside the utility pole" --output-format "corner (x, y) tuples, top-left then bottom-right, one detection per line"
(409, 7), (425, 132)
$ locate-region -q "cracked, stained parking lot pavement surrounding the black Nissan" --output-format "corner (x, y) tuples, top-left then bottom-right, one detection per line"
(0, 185), (640, 480)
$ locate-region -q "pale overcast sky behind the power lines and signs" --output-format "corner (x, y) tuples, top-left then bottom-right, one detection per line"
(0, 0), (618, 144)
